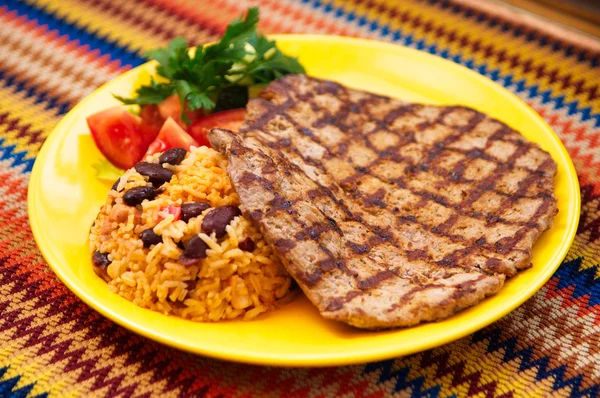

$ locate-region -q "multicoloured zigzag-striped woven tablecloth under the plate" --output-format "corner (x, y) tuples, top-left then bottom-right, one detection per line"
(0, 0), (600, 397)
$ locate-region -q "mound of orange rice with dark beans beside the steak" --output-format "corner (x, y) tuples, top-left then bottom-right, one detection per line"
(90, 147), (291, 321)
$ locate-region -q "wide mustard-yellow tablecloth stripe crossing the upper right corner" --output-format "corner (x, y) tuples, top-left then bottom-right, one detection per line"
(325, 0), (600, 112)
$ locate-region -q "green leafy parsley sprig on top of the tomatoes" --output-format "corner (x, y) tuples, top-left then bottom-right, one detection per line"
(115, 7), (305, 122)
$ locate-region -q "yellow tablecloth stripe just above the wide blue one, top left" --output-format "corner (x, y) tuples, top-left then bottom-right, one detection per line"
(26, 0), (166, 53)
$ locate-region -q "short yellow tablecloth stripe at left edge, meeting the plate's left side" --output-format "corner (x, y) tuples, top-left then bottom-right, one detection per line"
(0, 85), (60, 159)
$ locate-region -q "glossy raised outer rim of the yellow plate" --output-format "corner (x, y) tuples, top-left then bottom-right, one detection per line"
(27, 34), (581, 367)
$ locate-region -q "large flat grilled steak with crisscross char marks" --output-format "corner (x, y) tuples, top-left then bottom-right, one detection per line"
(209, 75), (557, 328)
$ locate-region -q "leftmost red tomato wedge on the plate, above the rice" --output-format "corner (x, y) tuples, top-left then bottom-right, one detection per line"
(86, 106), (149, 169)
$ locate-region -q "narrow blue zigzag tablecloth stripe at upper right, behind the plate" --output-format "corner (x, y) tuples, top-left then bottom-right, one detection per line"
(300, 0), (600, 127)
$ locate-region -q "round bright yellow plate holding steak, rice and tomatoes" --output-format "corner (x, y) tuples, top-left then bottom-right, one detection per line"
(29, 35), (580, 366)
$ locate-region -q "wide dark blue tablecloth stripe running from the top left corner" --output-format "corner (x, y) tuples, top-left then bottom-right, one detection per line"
(3, 0), (146, 66)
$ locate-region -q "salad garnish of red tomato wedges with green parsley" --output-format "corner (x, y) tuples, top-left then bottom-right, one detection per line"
(87, 7), (305, 174)
